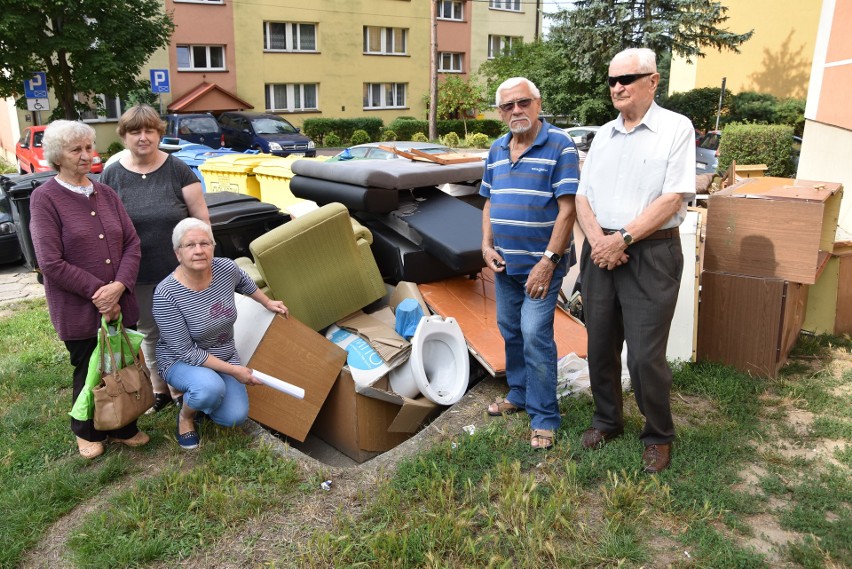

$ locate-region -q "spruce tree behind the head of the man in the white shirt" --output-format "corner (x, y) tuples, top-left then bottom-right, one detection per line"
(550, 0), (752, 81)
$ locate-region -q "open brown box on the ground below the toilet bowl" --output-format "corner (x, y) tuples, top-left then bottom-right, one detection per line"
(311, 367), (438, 462)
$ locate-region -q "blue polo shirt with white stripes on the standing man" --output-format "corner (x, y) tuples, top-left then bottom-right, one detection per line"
(479, 120), (579, 278)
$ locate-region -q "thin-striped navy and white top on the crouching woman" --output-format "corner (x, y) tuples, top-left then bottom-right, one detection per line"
(154, 257), (257, 377)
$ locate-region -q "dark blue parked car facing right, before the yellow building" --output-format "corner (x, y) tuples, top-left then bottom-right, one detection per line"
(219, 111), (317, 157)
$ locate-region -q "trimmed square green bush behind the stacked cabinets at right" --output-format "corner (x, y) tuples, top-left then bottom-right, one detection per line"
(719, 123), (795, 177)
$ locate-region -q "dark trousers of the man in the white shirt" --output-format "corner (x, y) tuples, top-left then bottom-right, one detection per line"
(580, 239), (683, 445)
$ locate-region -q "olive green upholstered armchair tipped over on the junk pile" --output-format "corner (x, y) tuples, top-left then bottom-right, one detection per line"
(243, 203), (385, 330)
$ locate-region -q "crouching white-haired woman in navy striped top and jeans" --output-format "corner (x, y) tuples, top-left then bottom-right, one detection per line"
(154, 217), (287, 449)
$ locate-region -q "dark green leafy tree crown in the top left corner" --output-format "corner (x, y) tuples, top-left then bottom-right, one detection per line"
(0, 0), (174, 119)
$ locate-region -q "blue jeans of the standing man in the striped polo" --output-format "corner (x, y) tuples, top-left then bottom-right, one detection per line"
(494, 273), (562, 431)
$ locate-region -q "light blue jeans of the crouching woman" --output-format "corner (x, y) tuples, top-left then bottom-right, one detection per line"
(166, 362), (248, 427)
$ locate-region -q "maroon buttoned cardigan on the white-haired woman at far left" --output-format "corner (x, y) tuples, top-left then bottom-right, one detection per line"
(30, 178), (142, 341)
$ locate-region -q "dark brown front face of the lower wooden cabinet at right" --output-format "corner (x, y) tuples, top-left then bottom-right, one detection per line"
(698, 271), (786, 377)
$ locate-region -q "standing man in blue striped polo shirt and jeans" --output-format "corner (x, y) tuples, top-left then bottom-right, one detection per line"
(480, 77), (579, 449)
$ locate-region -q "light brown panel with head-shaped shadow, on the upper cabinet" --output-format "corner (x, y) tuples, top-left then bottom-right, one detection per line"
(704, 197), (825, 284)
